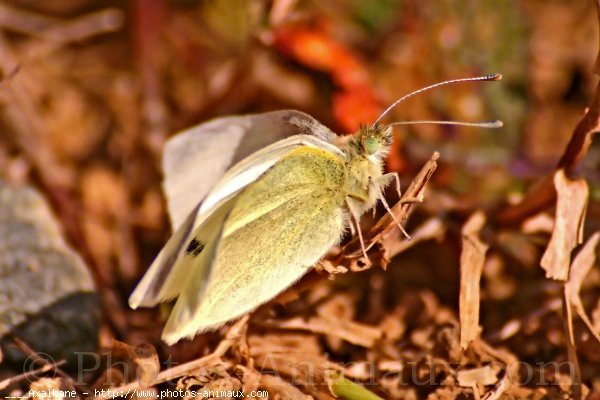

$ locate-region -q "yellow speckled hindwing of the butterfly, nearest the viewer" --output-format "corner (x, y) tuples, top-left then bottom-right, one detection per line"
(163, 146), (345, 344)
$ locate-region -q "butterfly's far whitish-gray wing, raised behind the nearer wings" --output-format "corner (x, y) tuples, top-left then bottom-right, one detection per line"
(163, 110), (335, 231)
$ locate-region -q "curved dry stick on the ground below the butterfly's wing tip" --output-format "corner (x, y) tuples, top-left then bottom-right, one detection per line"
(88, 315), (250, 400)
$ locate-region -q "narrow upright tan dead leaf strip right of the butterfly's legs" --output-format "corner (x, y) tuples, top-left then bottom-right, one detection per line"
(459, 211), (488, 350)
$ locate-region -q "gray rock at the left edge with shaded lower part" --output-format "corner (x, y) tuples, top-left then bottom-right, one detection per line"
(0, 181), (99, 361)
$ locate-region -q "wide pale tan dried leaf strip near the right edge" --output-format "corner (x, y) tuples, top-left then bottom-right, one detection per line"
(541, 169), (589, 281)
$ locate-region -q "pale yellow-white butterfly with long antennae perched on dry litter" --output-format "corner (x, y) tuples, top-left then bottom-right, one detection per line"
(129, 75), (499, 344)
